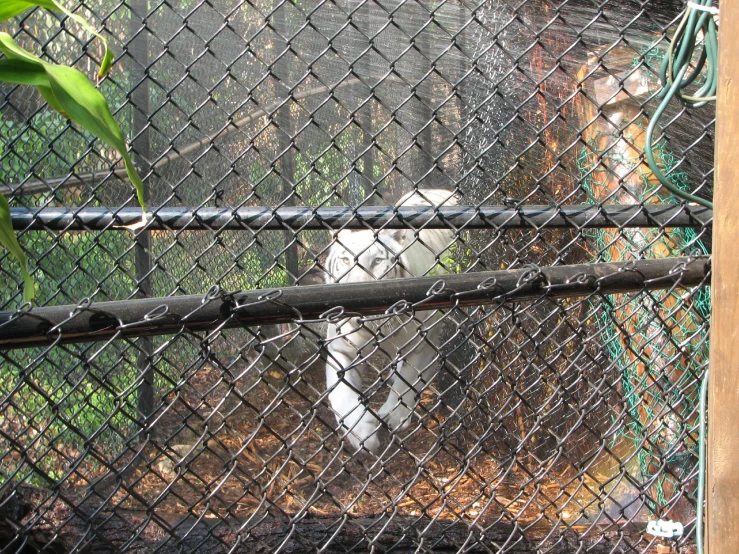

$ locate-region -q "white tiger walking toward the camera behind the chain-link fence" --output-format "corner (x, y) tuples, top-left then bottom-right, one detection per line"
(326, 189), (456, 454)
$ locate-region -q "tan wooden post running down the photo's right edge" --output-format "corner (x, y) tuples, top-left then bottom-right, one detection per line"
(705, 2), (739, 554)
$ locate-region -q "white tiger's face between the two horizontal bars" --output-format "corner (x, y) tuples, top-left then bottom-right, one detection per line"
(327, 230), (409, 283)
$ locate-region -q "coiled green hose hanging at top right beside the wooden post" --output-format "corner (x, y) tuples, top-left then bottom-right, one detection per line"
(645, 0), (718, 208)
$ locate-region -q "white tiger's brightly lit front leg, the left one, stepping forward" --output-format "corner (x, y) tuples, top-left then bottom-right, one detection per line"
(326, 324), (381, 454)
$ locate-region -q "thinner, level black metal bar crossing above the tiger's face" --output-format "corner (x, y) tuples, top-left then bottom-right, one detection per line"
(10, 204), (713, 231)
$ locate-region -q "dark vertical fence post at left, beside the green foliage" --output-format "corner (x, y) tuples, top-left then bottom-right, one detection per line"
(128, 0), (154, 419)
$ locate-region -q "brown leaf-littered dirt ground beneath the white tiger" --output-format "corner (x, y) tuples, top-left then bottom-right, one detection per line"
(60, 324), (656, 526)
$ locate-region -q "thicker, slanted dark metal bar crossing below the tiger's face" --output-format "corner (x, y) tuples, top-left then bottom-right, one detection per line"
(0, 253), (710, 349)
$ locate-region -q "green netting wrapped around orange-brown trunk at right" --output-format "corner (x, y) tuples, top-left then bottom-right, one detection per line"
(578, 132), (711, 511)
